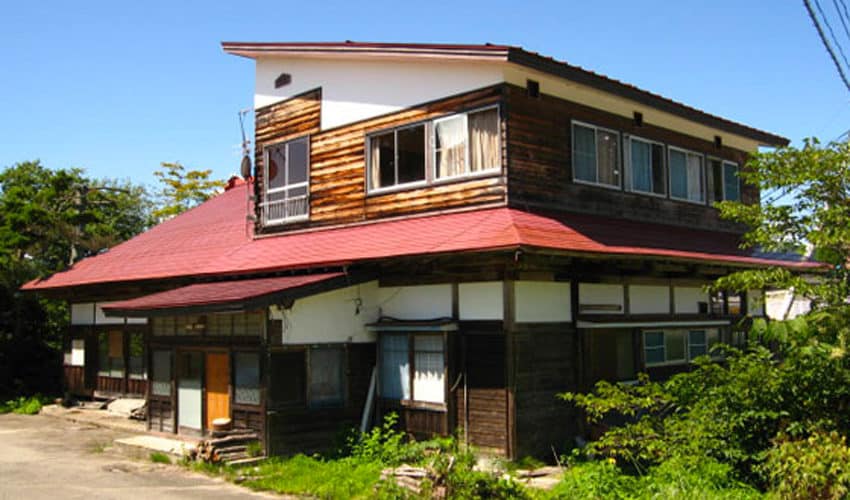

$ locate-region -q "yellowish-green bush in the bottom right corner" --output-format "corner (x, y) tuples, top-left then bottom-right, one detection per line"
(763, 431), (850, 500)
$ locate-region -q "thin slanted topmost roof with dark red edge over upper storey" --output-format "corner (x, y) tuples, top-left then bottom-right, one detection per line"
(221, 41), (789, 146)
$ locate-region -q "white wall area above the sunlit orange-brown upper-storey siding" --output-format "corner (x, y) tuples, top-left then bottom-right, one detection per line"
(254, 57), (504, 130)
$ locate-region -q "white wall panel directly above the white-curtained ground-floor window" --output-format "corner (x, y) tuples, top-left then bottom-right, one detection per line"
(378, 284), (452, 320)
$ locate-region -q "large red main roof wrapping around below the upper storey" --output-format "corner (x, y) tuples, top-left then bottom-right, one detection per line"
(23, 184), (819, 290)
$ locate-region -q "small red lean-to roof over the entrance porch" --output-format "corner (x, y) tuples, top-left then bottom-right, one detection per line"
(103, 273), (344, 313)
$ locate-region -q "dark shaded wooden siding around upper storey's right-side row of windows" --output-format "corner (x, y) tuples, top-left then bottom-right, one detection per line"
(506, 85), (759, 232)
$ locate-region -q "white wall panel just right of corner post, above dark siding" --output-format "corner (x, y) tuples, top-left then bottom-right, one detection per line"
(514, 281), (573, 323)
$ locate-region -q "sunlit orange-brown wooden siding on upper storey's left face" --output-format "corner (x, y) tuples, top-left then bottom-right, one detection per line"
(255, 86), (506, 233)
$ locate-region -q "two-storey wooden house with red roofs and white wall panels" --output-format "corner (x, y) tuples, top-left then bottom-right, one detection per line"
(25, 42), (813, 456)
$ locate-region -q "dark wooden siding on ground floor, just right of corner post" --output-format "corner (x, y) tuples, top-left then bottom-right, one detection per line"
(513, 323), (580, 459)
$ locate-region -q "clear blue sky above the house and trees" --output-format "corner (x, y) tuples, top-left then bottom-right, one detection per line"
(0, 0), (850, 187)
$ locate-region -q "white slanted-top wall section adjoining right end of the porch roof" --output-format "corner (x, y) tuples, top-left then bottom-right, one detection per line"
(272, 281), (378, 344)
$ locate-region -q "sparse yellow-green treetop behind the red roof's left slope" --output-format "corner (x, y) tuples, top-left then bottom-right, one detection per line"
(153, 162), (225, 221)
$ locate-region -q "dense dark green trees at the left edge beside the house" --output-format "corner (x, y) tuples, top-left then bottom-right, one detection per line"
(0, 161), (151, 396)
